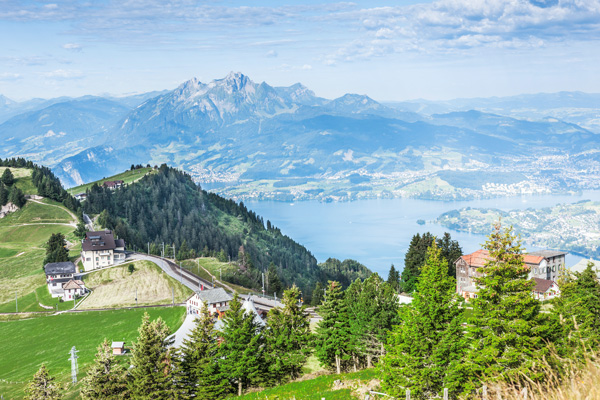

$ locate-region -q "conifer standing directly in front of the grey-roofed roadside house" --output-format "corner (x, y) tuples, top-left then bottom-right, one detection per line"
(176, 303), (230, 400)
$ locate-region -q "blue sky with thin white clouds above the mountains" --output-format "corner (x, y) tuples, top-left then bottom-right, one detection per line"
(0, 0), (600, 101)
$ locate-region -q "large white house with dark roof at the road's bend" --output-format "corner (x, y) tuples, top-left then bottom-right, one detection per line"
(81, 230), (126, 271)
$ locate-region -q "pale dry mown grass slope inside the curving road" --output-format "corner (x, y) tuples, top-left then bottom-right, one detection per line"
(79, 261), (192, 309)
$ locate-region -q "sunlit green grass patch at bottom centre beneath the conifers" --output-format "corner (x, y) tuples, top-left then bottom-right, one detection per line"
(238, 369), (379, 400)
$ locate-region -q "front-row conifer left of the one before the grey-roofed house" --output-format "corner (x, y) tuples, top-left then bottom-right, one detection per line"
(128, 313), (173, 400)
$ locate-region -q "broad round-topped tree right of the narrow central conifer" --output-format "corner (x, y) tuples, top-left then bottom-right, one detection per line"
(345, 273), (399, 370)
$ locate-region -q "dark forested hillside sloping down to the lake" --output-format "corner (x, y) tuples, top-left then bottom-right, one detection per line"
(84, 164), (360, 296)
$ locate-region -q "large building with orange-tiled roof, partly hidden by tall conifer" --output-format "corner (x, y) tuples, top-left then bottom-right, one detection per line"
(455, 250), (566, 300)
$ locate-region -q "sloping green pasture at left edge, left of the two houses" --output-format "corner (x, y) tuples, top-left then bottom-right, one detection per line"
(0, 200), (79, 312)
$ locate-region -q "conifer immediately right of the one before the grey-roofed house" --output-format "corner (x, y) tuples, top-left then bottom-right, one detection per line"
(218, 293), (265, 396)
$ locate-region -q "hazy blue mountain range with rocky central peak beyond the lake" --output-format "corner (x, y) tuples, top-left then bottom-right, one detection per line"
(0, 73), (600, 201)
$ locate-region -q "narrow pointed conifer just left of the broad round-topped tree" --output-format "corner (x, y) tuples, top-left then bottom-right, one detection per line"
(315, 281), (351, 374)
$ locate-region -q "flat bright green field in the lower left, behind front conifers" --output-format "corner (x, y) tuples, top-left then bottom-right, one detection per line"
(0, 307), (185, 399)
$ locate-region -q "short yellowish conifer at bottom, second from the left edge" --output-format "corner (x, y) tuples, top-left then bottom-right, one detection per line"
(81, 339), (129, 400)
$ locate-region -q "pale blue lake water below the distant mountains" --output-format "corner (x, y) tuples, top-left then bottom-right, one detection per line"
(245, 191), (600, 278)
